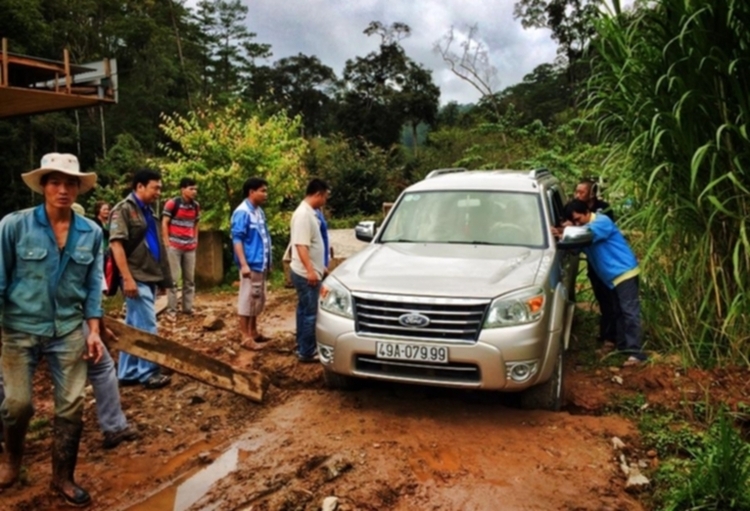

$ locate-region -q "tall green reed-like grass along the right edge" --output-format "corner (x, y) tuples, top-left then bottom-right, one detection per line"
(588, 0), (750, 364)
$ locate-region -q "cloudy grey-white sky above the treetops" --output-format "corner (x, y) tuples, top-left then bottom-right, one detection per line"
(220, 0), (557, 104)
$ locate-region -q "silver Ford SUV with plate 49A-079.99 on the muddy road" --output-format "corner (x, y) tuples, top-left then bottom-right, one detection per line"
(316, 169), (591, 410)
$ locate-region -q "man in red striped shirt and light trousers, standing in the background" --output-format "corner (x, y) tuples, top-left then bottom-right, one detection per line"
(162, 177), (200, 320)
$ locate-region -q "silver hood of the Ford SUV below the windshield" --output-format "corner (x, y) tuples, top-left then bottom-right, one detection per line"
(333, 243), (545, 298)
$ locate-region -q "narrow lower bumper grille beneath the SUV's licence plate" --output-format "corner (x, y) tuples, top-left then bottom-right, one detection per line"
(355, 355), (482, 383)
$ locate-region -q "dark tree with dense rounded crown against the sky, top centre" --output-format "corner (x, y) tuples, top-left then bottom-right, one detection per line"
(337, 22), (440, 147)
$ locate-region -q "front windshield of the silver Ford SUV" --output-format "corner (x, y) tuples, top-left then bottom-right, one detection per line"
(380, 190), (546, 247)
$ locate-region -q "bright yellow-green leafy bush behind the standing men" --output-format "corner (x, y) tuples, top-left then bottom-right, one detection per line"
(160, 102), (307, 240)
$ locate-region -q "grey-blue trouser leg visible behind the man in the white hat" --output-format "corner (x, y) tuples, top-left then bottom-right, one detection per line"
(0, 330), (128, 433)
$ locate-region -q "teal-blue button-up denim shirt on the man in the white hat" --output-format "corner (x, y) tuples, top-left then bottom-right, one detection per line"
(0, 205), (103, 337)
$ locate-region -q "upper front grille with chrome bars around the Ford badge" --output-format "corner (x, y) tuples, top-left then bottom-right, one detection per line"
(354, 294), (489, 344)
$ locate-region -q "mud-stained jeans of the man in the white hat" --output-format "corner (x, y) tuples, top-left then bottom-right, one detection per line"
(0, 326), (86, 427)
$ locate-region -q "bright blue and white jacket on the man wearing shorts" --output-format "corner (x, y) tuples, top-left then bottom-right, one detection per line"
(232, 199), (271, 272)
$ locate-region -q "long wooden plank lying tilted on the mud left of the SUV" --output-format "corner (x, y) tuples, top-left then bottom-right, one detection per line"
(106, 317), (268, 403)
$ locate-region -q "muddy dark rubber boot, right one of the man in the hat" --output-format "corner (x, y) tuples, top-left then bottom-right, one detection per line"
(52, 417), (91, 507)
